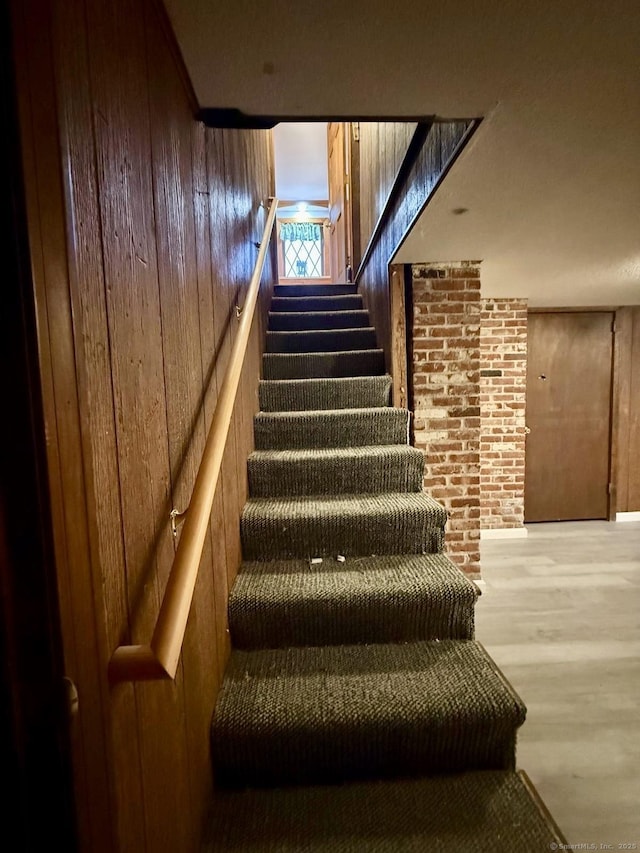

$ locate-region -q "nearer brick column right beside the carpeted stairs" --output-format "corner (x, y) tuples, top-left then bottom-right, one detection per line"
(412, 261), (480, 577)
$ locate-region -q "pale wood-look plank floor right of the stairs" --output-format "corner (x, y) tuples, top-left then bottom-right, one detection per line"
(476, 521), (640, 850)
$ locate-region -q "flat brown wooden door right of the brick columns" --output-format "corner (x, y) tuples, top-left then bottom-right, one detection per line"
(525, 311), (614, 522)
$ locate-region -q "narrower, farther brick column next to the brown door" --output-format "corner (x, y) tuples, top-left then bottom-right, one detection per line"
(480, 299), (527, 530)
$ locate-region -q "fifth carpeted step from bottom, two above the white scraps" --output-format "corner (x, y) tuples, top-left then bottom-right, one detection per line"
(247, 444), (424, 498)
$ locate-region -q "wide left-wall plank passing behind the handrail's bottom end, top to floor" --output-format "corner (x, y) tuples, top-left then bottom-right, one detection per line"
(86, 0), (189, 849)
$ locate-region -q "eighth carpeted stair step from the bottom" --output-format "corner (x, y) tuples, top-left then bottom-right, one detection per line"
(262, 349), (385, 379)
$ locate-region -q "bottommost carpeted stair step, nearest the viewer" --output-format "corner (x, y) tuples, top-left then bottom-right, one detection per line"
(203, 770), (567, 853)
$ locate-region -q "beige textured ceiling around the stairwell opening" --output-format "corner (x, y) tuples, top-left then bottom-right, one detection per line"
(165, 0), (640, 306)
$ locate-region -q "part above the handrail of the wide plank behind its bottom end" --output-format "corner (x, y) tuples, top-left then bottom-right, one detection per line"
(87, 0), (173, 642)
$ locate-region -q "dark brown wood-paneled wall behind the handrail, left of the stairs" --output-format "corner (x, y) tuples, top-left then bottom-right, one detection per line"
(13, 0), (275, 853)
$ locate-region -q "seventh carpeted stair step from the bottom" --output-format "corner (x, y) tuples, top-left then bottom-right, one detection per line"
(258, 375), (391, 412)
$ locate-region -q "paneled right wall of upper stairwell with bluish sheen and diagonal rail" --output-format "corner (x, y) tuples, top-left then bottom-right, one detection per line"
(357, 121), (473, 366)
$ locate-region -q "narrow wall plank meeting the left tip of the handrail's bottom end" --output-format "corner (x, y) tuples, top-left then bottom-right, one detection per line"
(50, 3), (144, 849)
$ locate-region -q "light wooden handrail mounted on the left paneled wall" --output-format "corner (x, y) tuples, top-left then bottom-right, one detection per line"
(109, 199), (278, 682)
